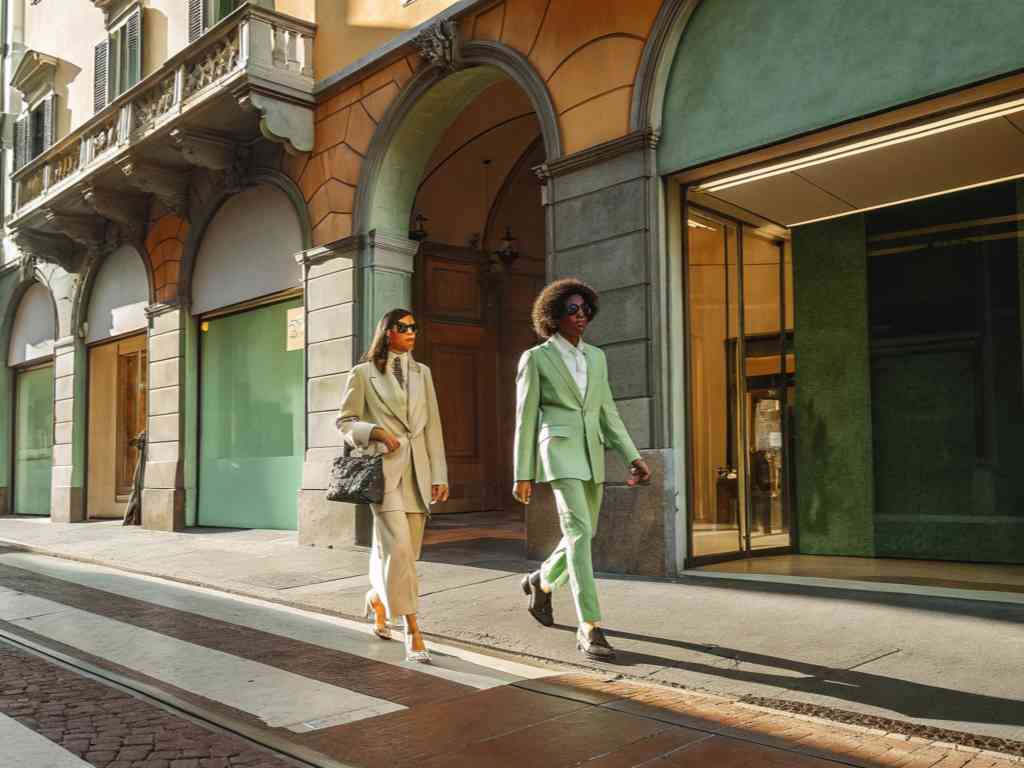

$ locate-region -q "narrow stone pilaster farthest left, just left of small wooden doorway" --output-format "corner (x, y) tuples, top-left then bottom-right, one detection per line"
(50, 336), (86, 522)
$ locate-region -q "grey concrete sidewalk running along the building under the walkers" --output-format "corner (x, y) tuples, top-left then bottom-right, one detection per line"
(0, 517), (1024, 741)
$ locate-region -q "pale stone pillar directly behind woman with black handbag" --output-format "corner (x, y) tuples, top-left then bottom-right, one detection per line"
(296, 238), (366, 547)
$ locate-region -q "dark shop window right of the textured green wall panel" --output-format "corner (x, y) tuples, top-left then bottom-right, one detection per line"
(867, 184), (1024, 536)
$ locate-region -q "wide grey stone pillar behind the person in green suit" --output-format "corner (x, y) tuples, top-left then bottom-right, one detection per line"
(526, 132), (683, 575)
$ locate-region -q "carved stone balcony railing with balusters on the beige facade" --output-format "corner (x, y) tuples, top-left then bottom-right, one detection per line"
(8, 5), (315, 219)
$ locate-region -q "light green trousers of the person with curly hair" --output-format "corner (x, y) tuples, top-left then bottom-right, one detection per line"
(541, 480), (604, 624)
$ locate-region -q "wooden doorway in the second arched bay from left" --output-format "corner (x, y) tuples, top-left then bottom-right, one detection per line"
(86, 333), (147, 518)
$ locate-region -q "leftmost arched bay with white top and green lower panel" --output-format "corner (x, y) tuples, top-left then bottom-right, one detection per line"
(7, 283), (56, 516)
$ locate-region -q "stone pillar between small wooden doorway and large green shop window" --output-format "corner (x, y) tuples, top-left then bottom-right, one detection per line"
(142, 302), (190, 530)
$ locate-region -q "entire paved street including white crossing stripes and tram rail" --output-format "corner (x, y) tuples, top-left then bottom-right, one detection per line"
(0, 548), (1013, 768)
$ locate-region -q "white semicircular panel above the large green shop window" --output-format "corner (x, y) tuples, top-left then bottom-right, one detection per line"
(191, 184), (302, 314)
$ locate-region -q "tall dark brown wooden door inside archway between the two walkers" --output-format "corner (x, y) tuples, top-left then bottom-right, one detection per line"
(414, 243), (544, 512)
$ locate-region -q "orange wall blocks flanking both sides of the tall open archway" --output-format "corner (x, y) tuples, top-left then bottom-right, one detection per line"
(307, 0), (662, 245)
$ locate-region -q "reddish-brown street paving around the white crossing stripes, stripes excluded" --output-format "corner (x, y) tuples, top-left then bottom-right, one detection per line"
(0, 566), (1024, 768)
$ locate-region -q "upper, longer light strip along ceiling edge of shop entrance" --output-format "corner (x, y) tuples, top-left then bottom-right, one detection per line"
(697, 98), (1024, 195)
